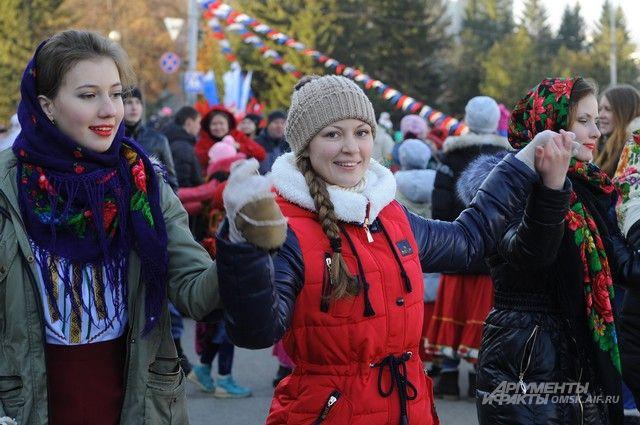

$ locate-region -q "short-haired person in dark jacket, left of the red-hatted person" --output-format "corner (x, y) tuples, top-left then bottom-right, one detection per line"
(164, 106), (203, 187)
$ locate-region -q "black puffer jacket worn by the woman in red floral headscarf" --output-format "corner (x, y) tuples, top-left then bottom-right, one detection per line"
(462, 158), (640, 425)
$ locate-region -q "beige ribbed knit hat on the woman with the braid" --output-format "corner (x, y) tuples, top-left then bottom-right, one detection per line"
(284, 75), (377, 154)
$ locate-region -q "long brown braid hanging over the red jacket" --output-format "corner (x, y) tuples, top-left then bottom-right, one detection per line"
(296, 151), (359, 299)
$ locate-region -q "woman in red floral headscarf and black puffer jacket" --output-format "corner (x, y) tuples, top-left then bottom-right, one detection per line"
(476, 78), (640, 425)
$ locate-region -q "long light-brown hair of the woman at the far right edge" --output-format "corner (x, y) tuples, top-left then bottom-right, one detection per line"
(595, 84), (640, 177)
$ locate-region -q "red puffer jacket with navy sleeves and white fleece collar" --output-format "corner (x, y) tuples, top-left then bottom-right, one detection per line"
(216, 153), (538, 425)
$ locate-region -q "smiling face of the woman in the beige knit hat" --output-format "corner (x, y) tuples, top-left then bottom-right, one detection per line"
(309, 119), (373, 188)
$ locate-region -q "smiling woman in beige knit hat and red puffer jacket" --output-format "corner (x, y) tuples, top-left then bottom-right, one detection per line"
(212, 75), (571, 425)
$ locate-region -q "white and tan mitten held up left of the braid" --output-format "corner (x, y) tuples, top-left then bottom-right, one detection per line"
(222, 158), (287, 249)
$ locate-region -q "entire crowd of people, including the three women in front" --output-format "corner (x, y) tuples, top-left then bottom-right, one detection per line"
(0, 30), (640, 425)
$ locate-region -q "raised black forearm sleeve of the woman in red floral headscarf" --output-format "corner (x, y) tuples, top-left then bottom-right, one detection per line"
(498, 179), (571, 271)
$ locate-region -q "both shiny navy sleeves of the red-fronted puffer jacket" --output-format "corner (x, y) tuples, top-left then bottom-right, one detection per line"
(217, 152), (552, 349)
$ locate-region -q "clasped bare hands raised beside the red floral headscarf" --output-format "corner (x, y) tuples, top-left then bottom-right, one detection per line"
(532, 130), (577, 190)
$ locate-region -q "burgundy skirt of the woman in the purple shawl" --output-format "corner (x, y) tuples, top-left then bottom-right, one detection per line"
(46, 336), (125, 425)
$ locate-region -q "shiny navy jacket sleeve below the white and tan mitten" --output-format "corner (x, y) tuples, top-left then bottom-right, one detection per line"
(216, 225), (304, 349)
